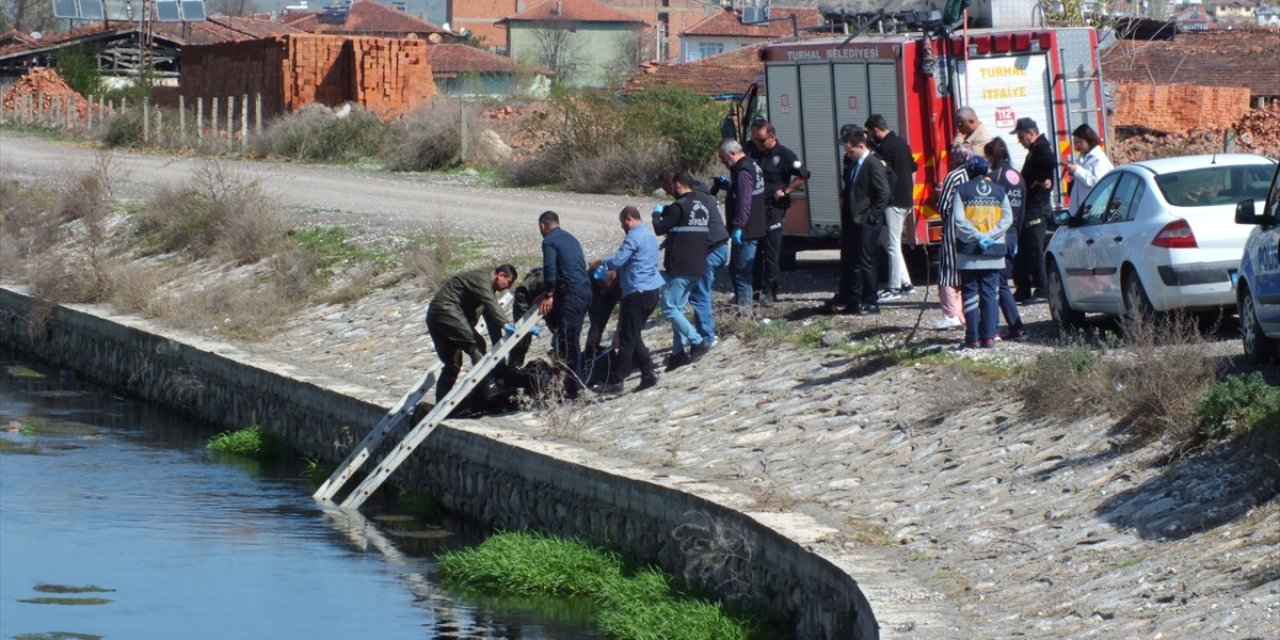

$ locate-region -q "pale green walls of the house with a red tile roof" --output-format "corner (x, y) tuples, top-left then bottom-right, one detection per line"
(509, 22), (637, 87)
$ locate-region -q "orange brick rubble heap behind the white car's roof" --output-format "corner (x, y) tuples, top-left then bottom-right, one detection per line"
(1108, 104), (1280, 164)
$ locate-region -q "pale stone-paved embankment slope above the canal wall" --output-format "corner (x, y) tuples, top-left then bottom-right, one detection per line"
(244, 270), (1280, 639)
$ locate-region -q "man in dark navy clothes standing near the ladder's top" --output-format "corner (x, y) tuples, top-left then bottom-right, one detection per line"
(538, 211), (591, 398)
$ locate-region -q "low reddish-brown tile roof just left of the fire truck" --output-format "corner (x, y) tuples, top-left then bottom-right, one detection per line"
(622, 46), (764, 96)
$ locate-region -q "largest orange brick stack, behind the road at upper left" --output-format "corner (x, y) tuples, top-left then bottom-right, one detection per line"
(182, 35), (435, 116)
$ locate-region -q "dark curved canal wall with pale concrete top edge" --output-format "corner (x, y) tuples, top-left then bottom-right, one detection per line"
(0, 288), (879, 640)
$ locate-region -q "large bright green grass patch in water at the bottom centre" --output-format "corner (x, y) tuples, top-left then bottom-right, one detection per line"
(438, 531), (777, 640)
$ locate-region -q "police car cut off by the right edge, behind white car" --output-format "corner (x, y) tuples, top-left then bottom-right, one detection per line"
(1235, 162), (1280, 364)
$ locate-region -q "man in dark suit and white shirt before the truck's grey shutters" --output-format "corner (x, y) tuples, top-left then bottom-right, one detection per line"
(822, 129), (890, 315)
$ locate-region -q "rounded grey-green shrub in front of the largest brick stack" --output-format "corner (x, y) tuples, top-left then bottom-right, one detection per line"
(253, 105), (388, 163)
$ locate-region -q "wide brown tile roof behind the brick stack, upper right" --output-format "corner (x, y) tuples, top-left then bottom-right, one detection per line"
(1102, 29), (1280, 97)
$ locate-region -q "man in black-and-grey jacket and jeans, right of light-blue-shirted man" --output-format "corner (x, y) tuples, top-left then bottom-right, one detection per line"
(653, 173), (719, 371)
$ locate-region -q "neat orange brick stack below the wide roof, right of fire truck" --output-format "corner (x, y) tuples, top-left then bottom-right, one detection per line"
(1112, 82), (1249, 133)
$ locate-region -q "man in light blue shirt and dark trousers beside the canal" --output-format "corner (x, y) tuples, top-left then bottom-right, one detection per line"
(591, 205), (663, 393)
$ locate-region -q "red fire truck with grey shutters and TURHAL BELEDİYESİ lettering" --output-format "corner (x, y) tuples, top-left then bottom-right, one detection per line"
(731, 20), (1107, 268)
